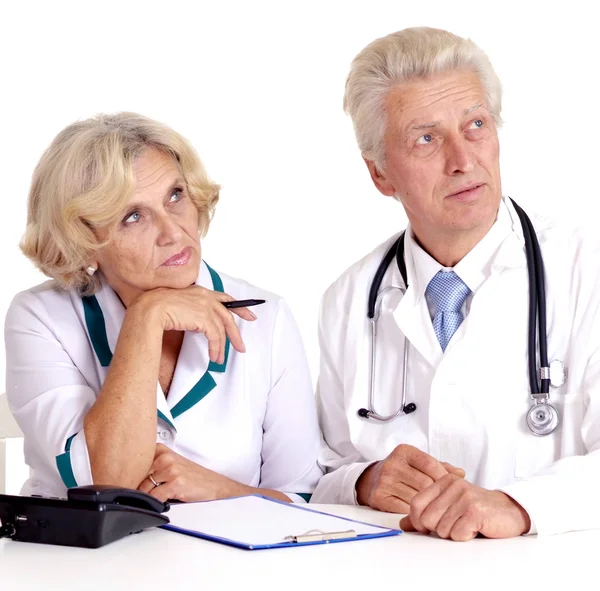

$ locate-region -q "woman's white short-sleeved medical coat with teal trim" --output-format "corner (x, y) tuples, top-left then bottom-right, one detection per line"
(5, 262), (322, 502)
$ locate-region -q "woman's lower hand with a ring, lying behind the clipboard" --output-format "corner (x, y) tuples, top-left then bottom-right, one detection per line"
(138, 443), (250, 502)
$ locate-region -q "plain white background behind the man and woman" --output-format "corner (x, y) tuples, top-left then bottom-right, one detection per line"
(0, 0), (600, 390)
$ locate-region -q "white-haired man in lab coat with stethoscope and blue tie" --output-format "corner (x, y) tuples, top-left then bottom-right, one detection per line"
(313, 28), (600, 540)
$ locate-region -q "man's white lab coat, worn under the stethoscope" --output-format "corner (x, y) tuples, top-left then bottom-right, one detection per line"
(312, 199), (600, 534)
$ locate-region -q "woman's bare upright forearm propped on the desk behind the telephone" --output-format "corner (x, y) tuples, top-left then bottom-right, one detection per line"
(84, 308), (163, 488)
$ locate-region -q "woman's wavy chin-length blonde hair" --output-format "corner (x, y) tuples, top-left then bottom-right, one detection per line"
(20, 113), (219, 295)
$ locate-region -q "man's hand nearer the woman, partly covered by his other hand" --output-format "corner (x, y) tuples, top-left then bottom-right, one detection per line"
(356, 445), (465, 513)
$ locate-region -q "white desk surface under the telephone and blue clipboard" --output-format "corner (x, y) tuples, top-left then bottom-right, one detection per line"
(0, 505), (600, 591)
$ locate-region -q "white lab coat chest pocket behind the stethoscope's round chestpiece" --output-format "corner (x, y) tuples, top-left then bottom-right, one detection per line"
(515, 389), (584, 478)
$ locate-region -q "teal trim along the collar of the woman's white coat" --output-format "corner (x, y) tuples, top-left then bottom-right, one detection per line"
(81, 262), (230, 427)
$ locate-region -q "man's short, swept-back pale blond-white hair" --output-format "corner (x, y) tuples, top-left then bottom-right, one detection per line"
(344, 27), (502, 168)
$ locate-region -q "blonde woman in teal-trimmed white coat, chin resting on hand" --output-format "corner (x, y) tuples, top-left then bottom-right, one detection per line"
(5, 113), (321, 502)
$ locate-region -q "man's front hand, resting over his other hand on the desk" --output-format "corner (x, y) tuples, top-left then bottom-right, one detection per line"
(400, 474), (531, 542)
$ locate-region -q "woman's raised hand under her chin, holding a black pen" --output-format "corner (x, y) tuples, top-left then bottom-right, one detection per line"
(127, 285), (256, 363)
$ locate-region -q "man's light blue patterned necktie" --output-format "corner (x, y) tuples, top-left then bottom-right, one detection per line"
(427, 271), (471, 351)
